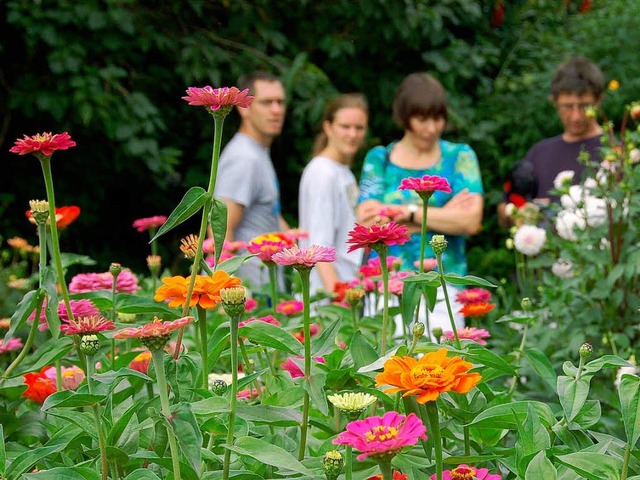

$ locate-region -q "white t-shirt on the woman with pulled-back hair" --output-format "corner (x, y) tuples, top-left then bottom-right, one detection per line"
(299, 157), (362, 293)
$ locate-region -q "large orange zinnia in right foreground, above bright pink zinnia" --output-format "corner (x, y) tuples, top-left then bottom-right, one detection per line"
(376, 348), (482, 403)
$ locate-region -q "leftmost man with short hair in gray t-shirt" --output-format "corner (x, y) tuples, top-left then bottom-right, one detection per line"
(215, 72), (288, 290)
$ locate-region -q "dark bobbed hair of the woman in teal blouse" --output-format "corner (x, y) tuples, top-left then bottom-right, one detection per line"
(393, 73), (447, 130)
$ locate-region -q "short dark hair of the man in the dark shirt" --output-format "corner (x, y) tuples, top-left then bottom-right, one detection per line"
(551, 57), (605, 99)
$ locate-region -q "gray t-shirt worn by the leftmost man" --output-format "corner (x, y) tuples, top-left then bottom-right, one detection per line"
(215, 132), (280, 289)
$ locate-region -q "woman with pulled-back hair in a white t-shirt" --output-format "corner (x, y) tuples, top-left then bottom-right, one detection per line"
(299, 93), (369, 292)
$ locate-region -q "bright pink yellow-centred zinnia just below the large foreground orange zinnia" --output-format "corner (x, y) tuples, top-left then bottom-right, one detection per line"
(333, 411), (427, 460)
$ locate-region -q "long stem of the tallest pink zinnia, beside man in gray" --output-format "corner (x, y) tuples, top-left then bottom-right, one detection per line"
(173, 117), (224, 360)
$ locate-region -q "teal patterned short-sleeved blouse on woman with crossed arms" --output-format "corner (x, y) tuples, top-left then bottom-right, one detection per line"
(358, 140), (484, 275)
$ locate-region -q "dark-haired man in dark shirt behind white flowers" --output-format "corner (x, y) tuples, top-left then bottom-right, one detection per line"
(498, 57), (605, 226)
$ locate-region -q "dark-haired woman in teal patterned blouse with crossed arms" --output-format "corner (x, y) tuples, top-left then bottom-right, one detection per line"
(356, 73), (484, 330)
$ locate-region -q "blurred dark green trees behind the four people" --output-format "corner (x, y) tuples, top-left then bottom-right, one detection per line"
(0, 0), (640, 278)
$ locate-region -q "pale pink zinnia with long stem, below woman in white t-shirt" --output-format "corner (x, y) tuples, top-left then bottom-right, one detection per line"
(271, 245), (336, 460)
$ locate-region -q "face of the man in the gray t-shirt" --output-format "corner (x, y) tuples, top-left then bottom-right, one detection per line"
(239, 80), (286, 145)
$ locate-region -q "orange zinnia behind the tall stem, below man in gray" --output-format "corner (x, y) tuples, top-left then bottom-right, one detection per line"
(153, 270), (241, 309)
